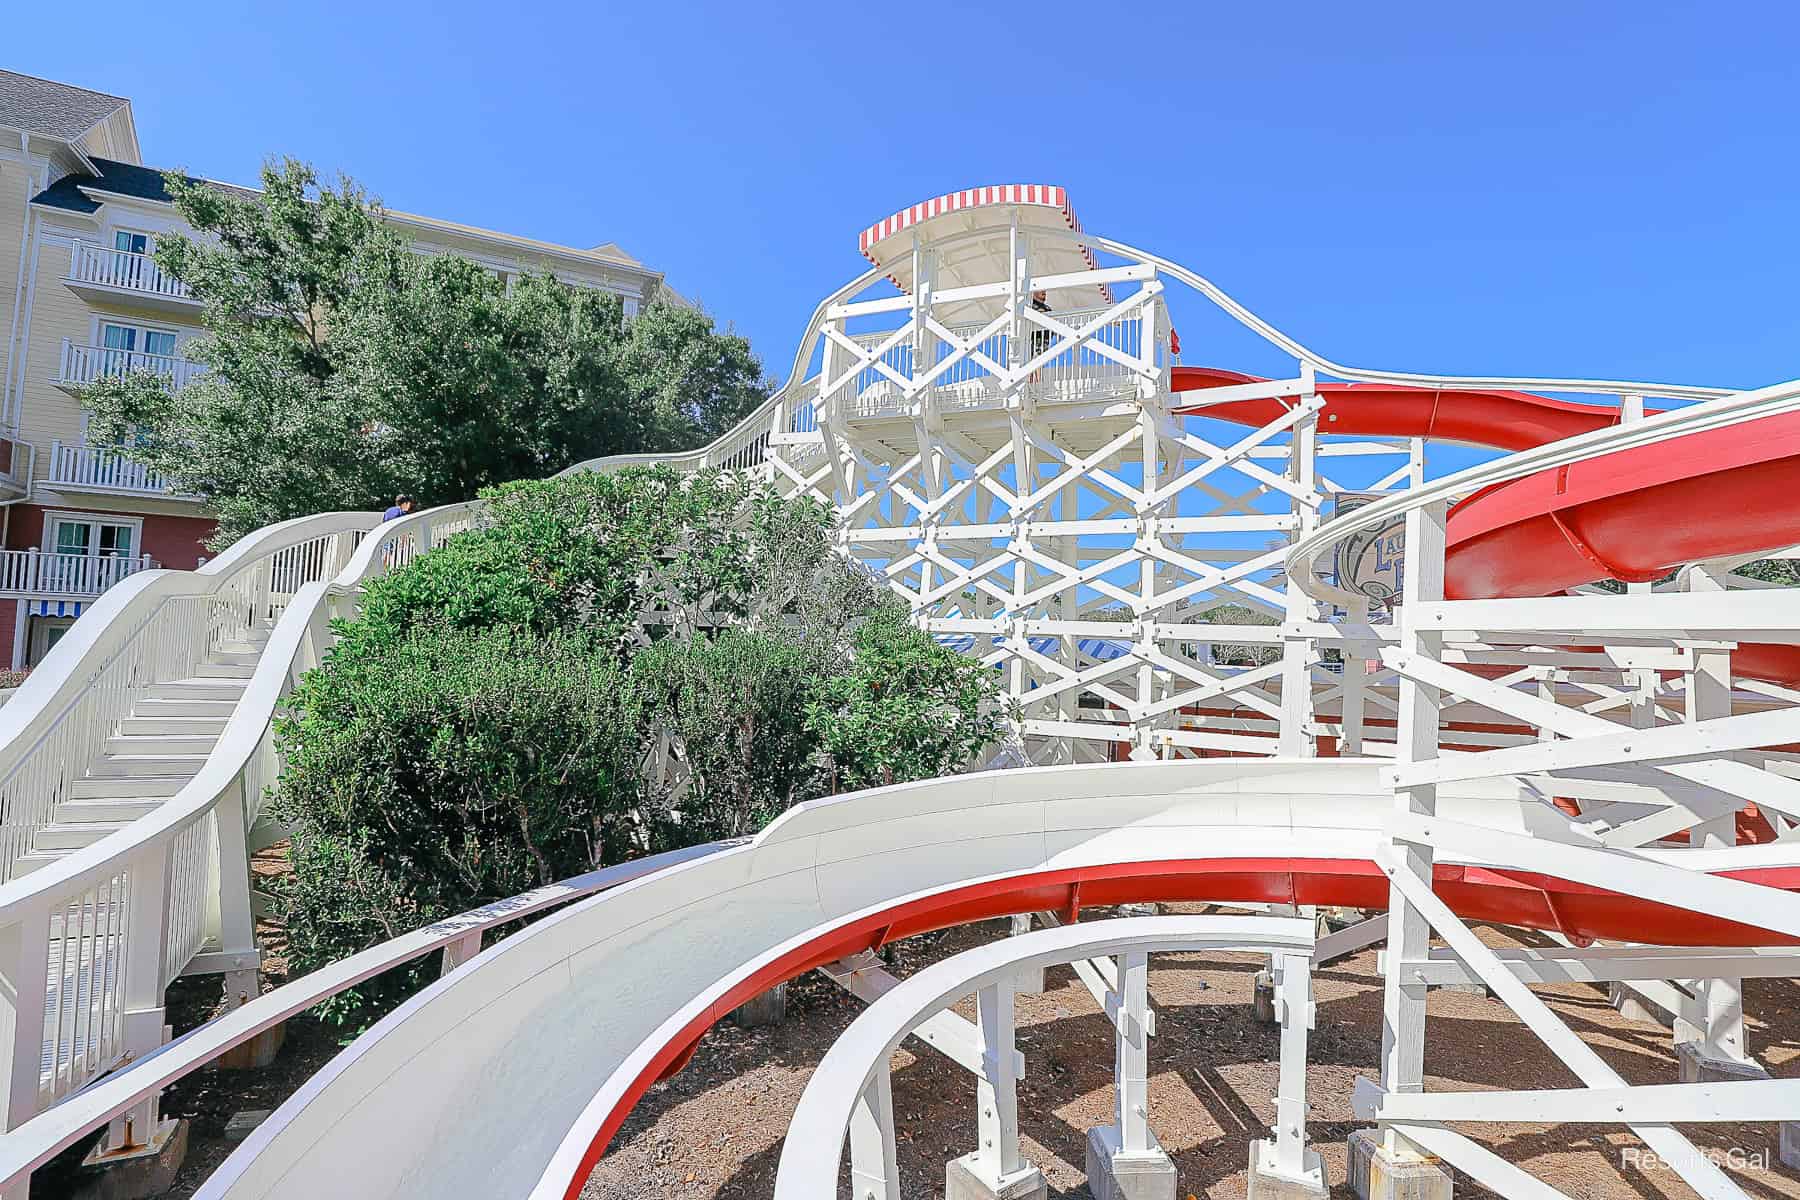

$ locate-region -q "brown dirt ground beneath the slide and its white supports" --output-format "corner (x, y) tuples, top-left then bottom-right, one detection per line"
(32, 895), (1800, 1200)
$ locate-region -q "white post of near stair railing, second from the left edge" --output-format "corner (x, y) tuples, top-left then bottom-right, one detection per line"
(101, 838), (176, 1150)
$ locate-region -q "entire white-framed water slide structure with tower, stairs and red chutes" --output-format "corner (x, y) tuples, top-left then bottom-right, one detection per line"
(0, 187), (1800, 1200)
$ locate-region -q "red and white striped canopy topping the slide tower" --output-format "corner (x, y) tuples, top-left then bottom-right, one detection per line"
(859, 184), (1112, 318)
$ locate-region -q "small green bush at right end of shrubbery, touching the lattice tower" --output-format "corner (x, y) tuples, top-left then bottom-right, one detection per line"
(806, 601), (1003, 790)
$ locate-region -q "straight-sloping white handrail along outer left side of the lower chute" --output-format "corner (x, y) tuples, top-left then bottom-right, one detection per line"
(0, 841), (723, 1193)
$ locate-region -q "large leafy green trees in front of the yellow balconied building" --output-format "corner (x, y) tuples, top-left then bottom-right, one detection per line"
(85, 160), (769, 543)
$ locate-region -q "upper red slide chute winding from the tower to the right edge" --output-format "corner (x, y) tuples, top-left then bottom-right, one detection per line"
(1174, 367), (1800, 684)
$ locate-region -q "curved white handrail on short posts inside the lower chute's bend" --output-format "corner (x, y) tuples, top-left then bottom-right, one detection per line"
(774, 916), (1312, 1200)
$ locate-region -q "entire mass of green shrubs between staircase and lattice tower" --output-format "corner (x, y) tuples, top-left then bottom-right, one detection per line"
(277, 468), (1003, 1027)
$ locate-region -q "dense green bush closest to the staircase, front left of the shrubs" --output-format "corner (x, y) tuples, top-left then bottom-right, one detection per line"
(275, 628), (641, 1018)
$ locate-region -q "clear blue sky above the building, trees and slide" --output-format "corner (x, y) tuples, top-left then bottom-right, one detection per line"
(14, 0), (1800, 385)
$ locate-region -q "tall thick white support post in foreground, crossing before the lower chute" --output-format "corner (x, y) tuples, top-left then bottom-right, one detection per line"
(1381, 502), (1447, 1153)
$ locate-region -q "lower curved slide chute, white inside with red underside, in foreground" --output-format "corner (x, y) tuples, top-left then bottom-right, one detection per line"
(198, 759), (1800, 1200)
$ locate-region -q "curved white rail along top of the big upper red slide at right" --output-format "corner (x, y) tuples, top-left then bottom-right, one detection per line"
(1285, 380), (1800, 604)
